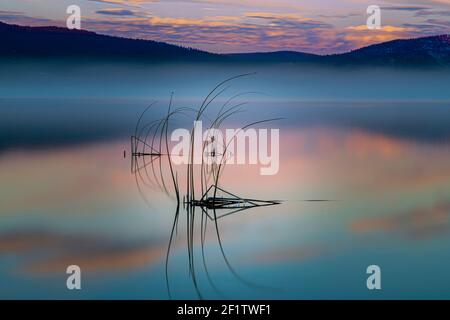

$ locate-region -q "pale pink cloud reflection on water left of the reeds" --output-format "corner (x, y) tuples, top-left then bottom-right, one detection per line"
(0, 143), (134, 215)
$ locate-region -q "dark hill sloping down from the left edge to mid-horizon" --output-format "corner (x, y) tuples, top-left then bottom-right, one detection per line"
(0, 22), (216, 60)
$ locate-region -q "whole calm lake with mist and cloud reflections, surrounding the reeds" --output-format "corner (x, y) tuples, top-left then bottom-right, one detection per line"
(0, 62), (450, 299)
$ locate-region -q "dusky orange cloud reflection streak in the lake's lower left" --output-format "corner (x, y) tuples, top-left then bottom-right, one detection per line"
(0, 230), (167, 274)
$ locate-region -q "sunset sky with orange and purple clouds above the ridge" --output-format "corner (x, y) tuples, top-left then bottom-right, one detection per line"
(0, 0), (450, 54)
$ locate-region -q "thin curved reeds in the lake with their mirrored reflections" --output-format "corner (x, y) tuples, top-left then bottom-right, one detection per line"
(124, 74), (281, 299)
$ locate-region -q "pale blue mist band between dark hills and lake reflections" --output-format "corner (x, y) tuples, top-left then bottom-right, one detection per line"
(0, 60), (450, 101)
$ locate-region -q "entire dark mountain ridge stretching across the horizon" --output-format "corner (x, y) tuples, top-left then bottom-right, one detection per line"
(0, 22), (450, 67)
